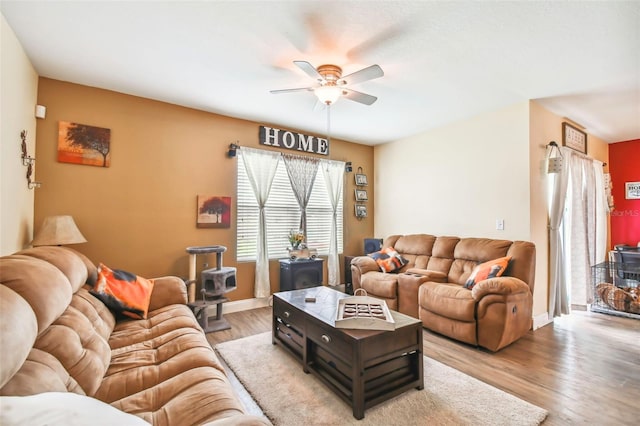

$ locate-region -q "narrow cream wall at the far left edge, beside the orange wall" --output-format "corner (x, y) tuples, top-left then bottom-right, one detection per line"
(0, 16), (38, 255)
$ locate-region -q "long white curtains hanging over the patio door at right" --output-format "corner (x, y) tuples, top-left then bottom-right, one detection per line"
(549, 147), (608, 317)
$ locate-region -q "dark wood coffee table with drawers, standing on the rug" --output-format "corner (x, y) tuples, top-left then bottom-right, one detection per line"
(273, 286), (424, 420)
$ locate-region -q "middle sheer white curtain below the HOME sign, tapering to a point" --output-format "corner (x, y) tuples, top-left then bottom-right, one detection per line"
(282, 154), (320, 236)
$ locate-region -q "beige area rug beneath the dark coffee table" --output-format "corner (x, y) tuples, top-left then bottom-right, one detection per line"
(215, 332), (548, 426)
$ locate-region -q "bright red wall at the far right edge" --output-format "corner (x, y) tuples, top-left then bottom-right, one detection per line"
(609, 139), (640, 248)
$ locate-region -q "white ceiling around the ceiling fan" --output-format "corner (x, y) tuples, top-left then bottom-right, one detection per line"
(0, 0), (640, 144)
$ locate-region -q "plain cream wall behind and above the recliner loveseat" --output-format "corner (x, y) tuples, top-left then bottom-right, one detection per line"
(374, 102), (530, 240)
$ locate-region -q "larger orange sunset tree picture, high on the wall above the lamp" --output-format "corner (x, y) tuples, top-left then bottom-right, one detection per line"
(58, 121), (111, 167)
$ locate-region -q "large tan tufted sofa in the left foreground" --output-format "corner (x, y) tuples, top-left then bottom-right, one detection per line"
(0, 247), (270, 426)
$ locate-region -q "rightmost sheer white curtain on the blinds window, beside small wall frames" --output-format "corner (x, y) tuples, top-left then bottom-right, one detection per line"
(321, 161), (345, 285)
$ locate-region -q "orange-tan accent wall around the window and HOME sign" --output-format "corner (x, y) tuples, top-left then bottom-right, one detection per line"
(34, 78), (374, 300)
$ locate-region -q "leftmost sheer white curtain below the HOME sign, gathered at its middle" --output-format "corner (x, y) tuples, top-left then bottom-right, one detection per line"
(240, 147), (280, 297)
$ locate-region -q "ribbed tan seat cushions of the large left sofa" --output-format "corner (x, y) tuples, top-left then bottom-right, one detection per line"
(95, 305), (243, 425)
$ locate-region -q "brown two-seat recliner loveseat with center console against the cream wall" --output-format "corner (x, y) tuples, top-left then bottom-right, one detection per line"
(351, 234), (535, 351)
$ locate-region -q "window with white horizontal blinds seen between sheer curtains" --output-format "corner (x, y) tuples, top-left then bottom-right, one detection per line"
(237, 151), (343, 261)
